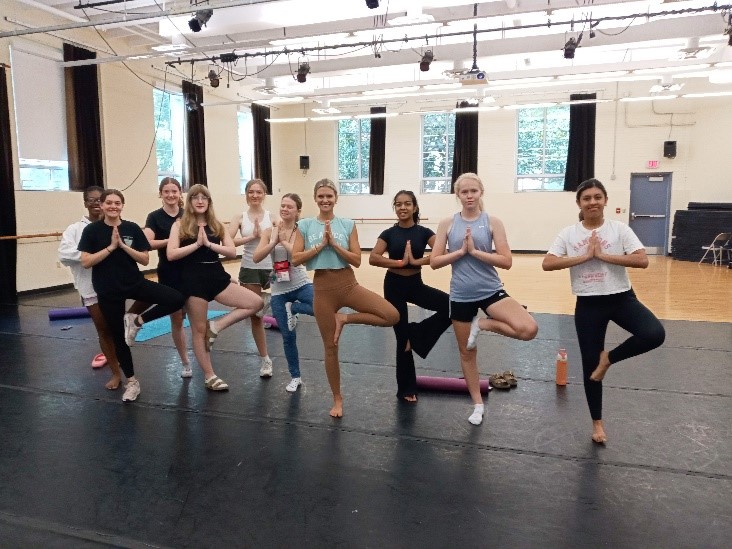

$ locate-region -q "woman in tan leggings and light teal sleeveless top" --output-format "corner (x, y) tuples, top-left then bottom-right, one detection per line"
(292, 179), (399, 417)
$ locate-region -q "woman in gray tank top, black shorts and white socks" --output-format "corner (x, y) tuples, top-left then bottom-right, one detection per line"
(430, 173), (538, 425)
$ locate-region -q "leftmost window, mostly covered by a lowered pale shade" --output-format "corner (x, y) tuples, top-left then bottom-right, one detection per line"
(10, 42), (69, 191)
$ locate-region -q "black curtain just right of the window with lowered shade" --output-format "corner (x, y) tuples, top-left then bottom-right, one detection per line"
(64, 44), (104, 191)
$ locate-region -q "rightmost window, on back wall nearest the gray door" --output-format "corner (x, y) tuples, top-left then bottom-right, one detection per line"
(516, 106), (569, 191)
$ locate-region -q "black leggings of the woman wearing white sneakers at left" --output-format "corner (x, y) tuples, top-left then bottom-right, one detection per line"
(99, 280), (185, 378)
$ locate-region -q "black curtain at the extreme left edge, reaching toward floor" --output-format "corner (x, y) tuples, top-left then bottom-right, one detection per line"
(0, 66), (18, 303)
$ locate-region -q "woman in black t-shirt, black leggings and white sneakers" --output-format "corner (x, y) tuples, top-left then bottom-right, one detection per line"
(79, 189), (184, 402)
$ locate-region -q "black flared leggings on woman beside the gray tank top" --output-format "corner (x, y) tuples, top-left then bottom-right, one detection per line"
(384, 271), (451, 398)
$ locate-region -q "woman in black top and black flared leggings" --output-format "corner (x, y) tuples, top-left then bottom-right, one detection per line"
(369, 191), (451, 402)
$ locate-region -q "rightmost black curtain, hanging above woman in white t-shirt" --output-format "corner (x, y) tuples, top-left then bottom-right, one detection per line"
(564, 93), (597, 192)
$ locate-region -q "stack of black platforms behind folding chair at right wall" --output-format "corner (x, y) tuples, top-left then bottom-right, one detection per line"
(671, 202), (732, 263)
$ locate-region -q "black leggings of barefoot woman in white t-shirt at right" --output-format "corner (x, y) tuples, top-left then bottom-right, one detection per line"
(574, 289), (666, 420)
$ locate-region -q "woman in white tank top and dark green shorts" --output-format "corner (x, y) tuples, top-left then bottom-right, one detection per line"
(229, 179), (277, 377)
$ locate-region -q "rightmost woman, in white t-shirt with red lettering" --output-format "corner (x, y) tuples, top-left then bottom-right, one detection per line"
(542, 179), (666, 444)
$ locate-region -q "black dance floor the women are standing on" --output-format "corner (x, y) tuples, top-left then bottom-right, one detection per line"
(0, 291), (732, 548)
